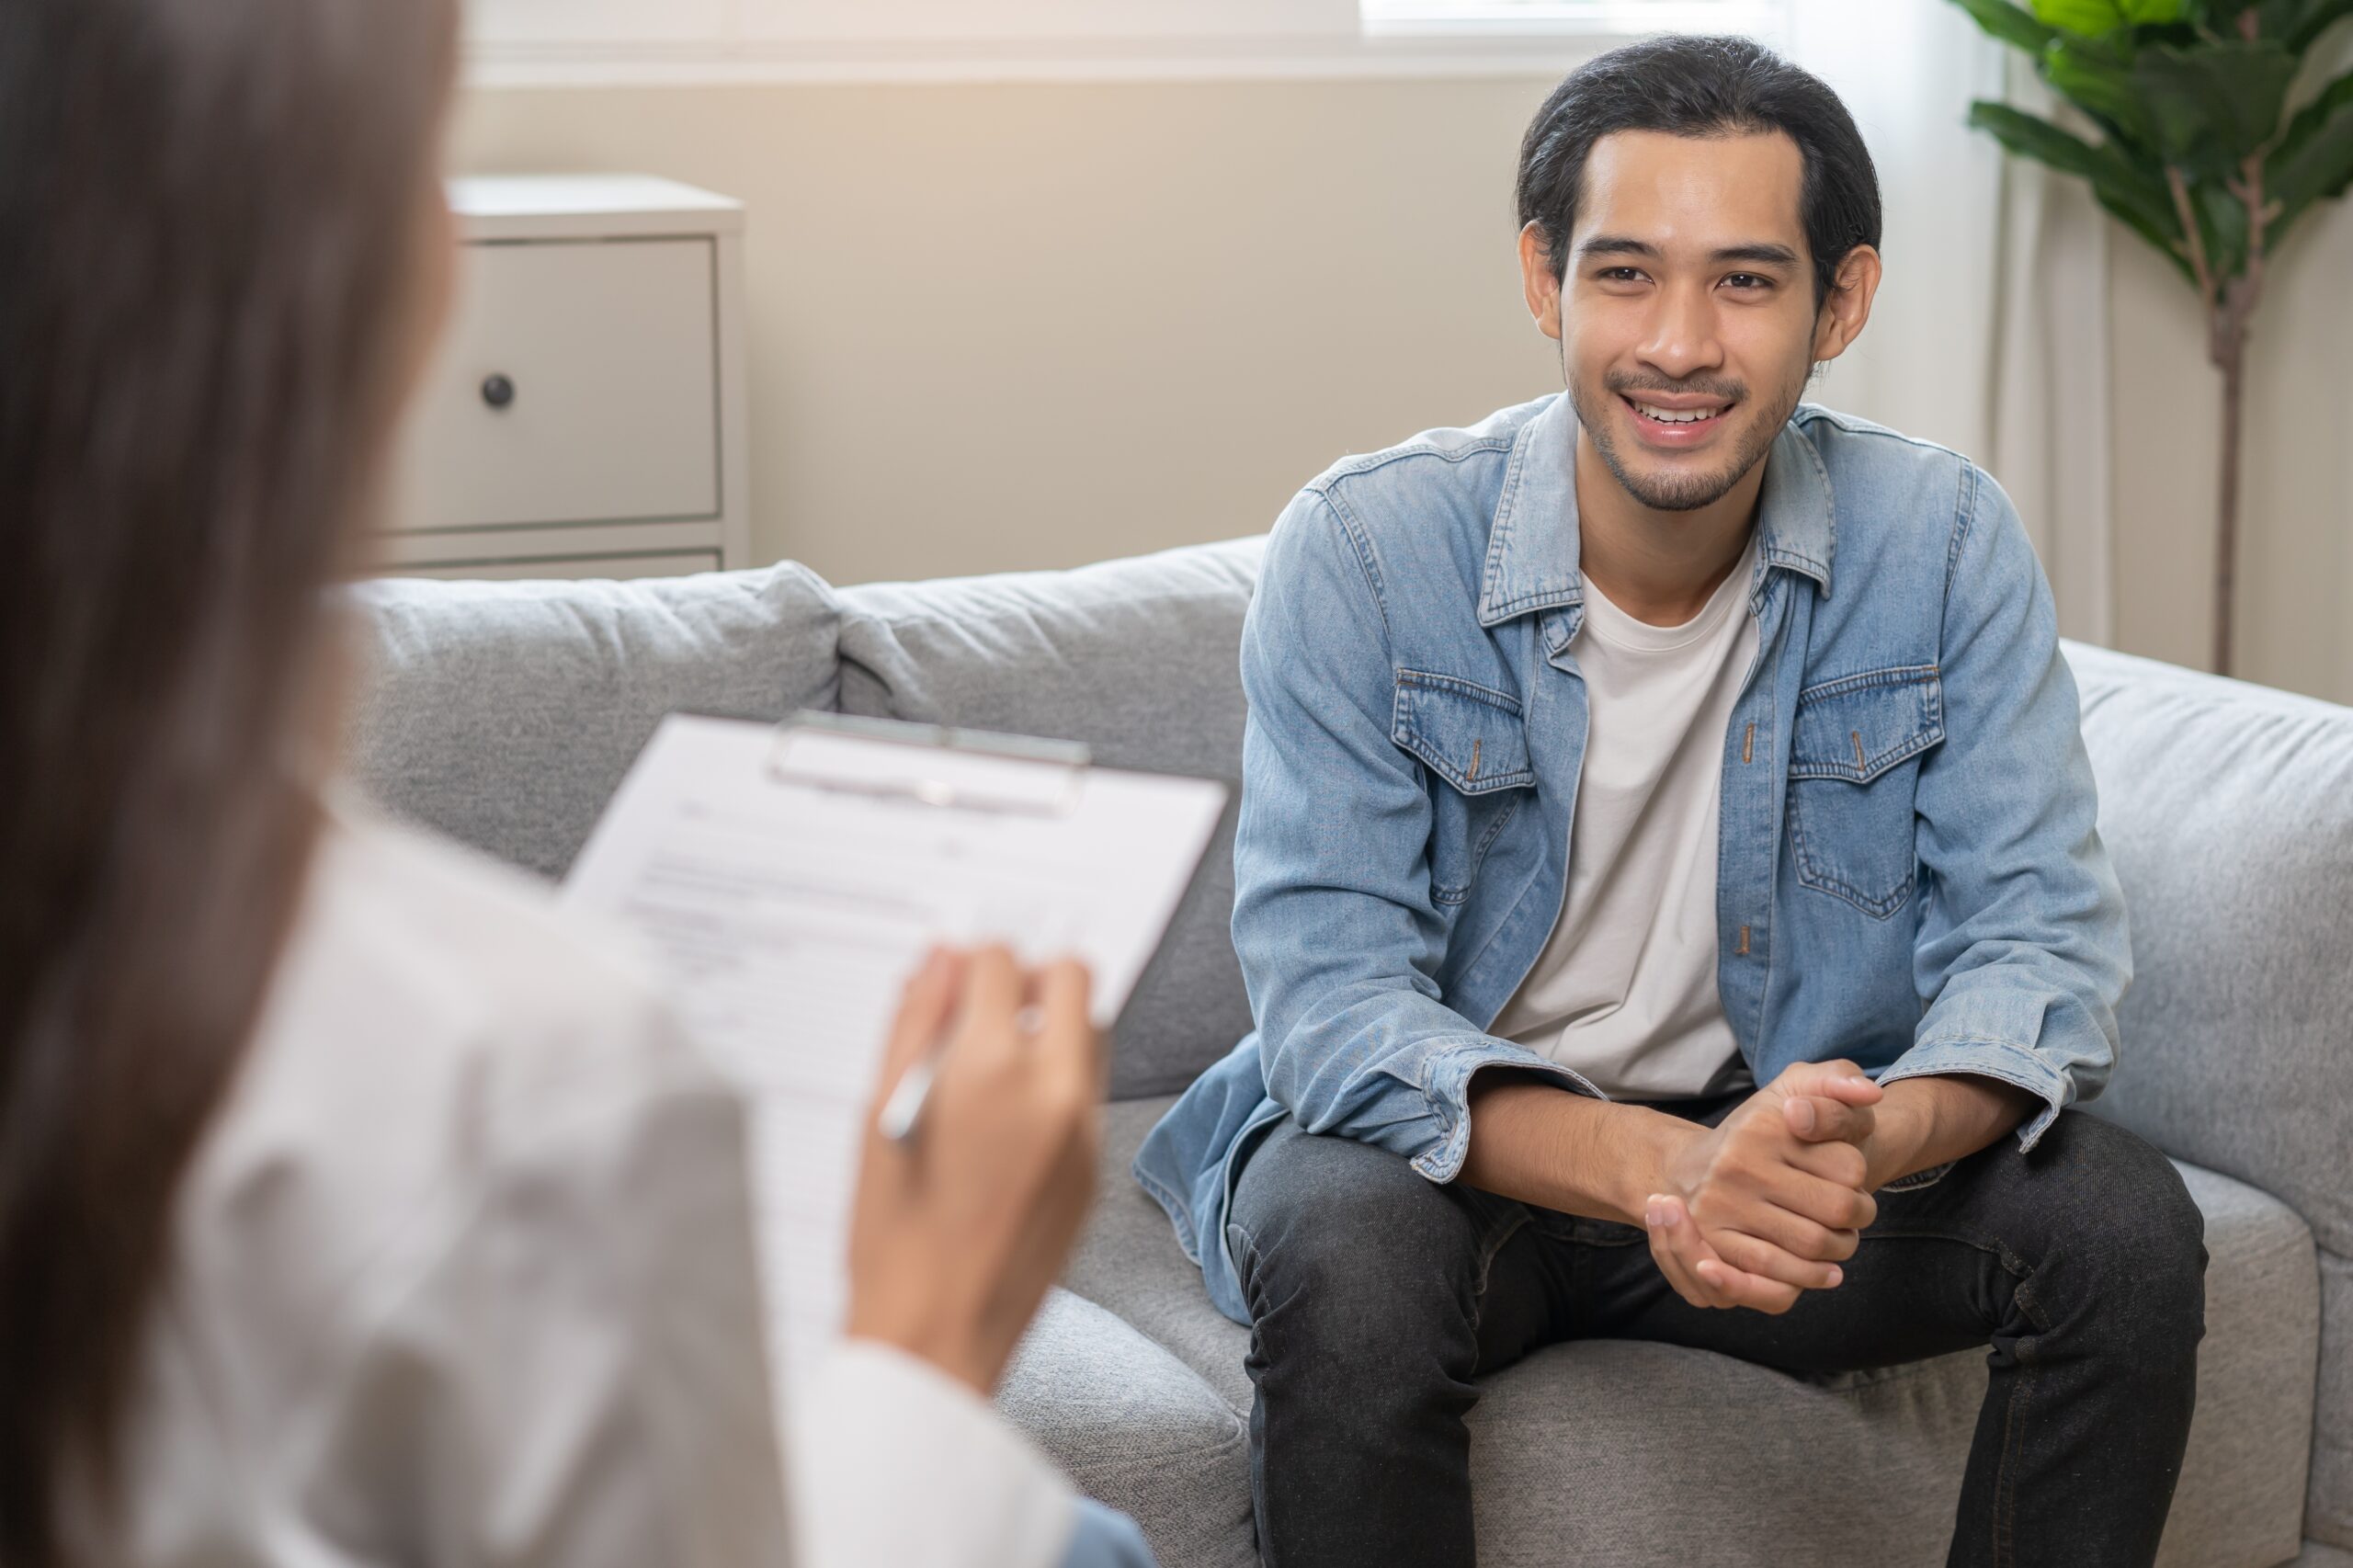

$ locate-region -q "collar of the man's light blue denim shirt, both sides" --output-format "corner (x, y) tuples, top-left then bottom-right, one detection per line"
(1478, 393), (1837, 626)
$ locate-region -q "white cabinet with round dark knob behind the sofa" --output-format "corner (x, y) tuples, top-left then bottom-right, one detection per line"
(377, 176), (751, 577)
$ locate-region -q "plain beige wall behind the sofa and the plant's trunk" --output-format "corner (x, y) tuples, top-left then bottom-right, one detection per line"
(454, 78), (2353, 701)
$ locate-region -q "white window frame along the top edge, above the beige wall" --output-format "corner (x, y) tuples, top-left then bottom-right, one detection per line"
(466, 0), (1779, 87)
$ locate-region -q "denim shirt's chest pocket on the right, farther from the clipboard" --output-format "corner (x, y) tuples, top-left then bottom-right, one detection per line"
(1789, 664), (1944, 921)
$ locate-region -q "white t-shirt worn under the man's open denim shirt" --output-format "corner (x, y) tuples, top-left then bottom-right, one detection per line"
(1492, 534), (1757, 1099)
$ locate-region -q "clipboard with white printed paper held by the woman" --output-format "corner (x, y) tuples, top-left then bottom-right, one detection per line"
(563, 713), (1228, 1380)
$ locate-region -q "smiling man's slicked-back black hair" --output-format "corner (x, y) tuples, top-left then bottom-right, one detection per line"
(1520, 35), (1880, 309)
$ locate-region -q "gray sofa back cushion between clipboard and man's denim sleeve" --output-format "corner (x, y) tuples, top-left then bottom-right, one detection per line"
(842, 540), (1264, 1099)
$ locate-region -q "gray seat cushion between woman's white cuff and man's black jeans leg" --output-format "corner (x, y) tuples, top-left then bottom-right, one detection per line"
(997, 1290), (1259, 1568)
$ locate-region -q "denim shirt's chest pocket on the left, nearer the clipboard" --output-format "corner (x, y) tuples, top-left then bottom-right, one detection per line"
(1391, 668), (1537, 904)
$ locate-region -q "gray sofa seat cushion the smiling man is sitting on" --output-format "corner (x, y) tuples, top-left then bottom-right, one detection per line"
(1066, 1099), (2315, 1568)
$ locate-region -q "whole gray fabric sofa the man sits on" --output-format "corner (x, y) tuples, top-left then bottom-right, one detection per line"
(350, 540), (2353, 1568)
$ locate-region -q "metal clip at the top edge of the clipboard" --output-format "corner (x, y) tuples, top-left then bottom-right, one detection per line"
(767, 709), (1094, 817)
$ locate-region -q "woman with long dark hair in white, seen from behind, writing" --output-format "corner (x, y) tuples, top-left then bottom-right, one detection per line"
(0, 0), (1139, 1568)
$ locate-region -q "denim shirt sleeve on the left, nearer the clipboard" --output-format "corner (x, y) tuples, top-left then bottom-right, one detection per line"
(1233, 490), (1591, 1182)
